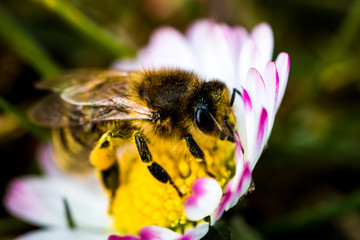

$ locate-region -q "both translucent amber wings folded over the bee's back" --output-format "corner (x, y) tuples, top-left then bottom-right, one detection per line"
(30, 70), (152, 128)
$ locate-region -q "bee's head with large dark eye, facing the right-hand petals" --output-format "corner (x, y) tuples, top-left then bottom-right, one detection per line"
(194, 81), (235, 142)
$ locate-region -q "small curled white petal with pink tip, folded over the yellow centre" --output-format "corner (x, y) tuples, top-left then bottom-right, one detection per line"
(185, 177), (222, 221)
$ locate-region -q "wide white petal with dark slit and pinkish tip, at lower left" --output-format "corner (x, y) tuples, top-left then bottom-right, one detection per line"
(5, 177), (111, 229)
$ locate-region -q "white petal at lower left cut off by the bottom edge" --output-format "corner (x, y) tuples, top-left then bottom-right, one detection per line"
(16, 228), (109, 240)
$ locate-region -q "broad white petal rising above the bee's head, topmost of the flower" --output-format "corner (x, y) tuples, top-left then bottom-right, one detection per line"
(187, 20), (236, 87)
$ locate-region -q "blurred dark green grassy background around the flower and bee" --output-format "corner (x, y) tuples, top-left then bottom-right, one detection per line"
(0, 0), (360, 240)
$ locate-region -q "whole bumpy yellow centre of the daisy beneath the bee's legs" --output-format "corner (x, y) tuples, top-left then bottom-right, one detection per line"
(102, 137), (234, 234)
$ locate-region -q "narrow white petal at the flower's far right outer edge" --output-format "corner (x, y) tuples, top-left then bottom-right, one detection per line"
(275, 53), (290, 110)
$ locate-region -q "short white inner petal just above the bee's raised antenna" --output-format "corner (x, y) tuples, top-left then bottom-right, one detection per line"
(236, 38), (266, 85)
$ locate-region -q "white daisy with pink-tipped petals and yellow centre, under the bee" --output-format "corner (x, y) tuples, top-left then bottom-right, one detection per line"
(5, 20), (290, 240)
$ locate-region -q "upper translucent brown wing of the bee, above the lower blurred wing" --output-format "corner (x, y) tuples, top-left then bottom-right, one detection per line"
(36, 69), (147, 109)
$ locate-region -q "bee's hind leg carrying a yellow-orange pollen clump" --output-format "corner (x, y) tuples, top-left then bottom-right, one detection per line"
(90, 131), (120, 201)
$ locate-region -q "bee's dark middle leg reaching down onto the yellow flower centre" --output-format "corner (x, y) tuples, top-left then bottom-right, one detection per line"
(134, 132), (183, 197)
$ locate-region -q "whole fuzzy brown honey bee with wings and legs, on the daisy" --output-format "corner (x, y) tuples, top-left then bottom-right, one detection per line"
(31, 69), (241, 197)
